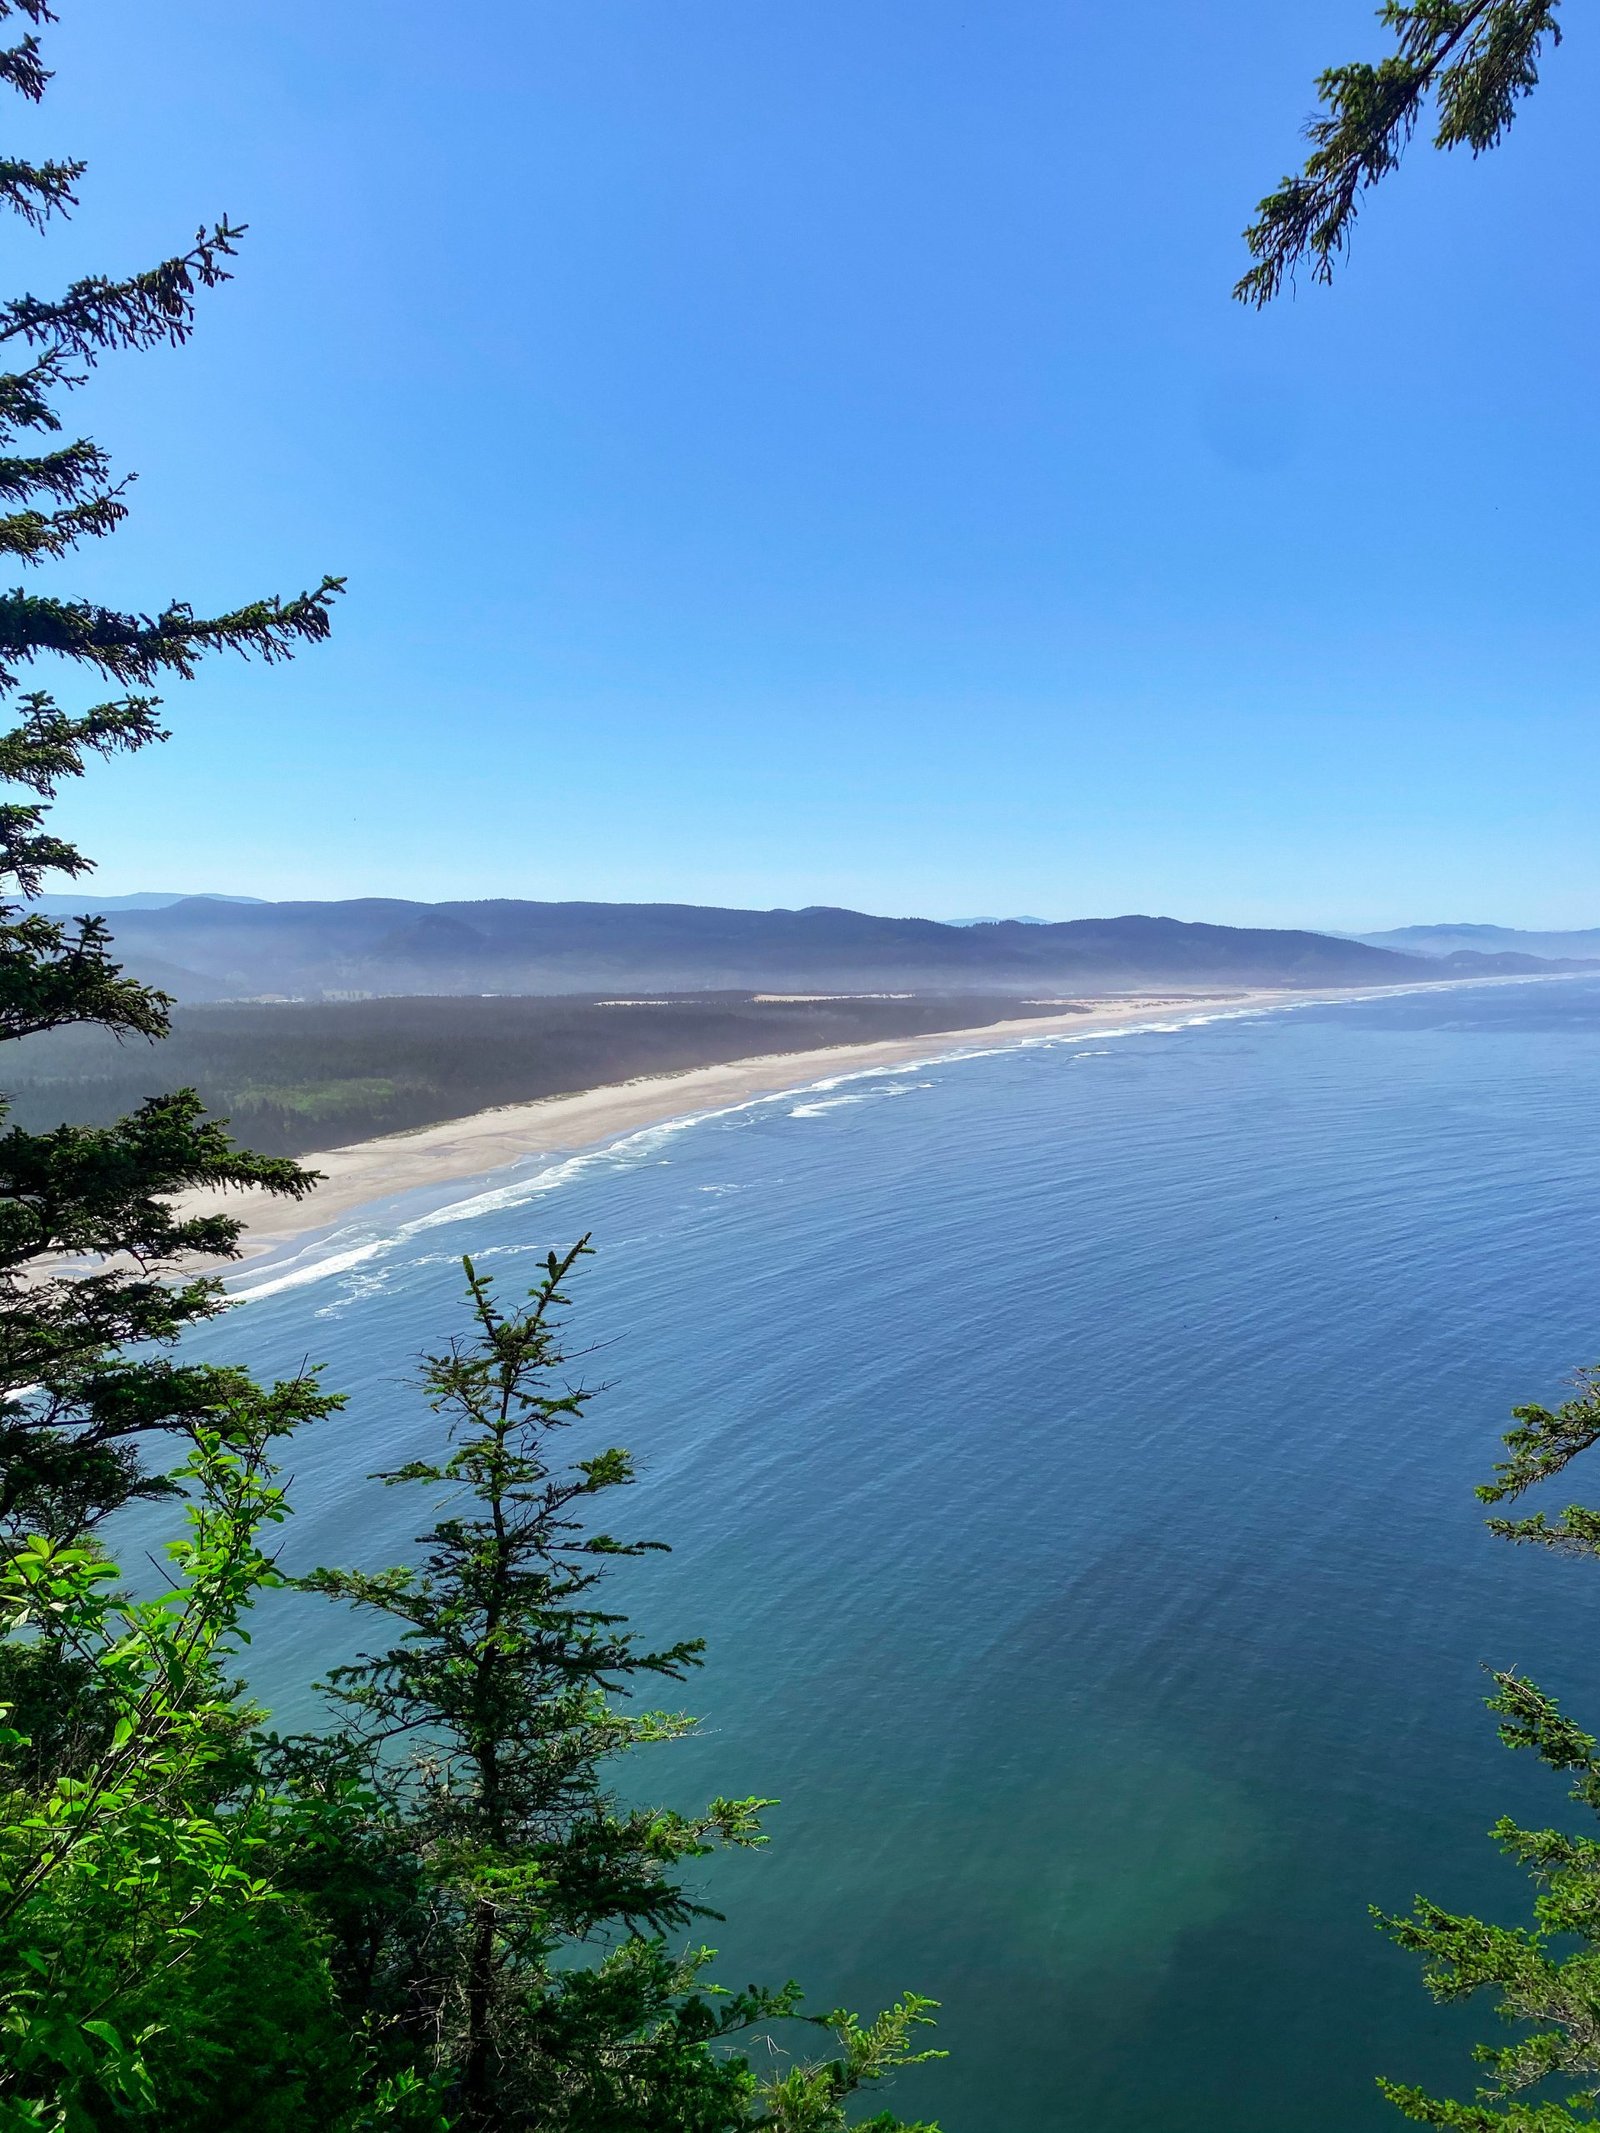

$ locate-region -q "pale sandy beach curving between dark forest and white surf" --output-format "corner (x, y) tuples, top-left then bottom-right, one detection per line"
(175, 979), (1390, 1280)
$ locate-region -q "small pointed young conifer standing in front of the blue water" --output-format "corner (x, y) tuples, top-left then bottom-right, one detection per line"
(294, 1241), (937, 2133)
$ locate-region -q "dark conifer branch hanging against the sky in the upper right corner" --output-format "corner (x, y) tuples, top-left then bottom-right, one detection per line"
(1233, 0), (1562, 305)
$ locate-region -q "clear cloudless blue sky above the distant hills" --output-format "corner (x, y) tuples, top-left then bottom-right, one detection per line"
(21, 0), (1600, 928)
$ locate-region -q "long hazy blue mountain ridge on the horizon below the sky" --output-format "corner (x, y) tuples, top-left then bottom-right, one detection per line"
(31, 896), (1595, 1003)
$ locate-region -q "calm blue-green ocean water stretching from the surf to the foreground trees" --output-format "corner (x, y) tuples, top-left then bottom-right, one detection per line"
(178, 981), (1600, 2133)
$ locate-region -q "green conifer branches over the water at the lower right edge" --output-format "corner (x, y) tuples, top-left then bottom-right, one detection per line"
(1376, 1372), (1600, 2133)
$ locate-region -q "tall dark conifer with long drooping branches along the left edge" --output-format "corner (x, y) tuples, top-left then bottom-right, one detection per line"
(0, 0), (339, 1569)
